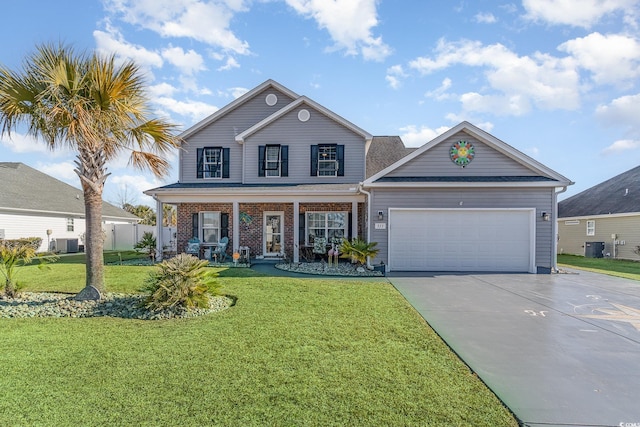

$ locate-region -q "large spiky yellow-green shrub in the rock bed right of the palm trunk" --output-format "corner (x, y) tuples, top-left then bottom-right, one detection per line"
(141, 254), (219, 310)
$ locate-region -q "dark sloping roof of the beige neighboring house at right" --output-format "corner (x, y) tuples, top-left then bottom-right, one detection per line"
(558, 166), (640, 218)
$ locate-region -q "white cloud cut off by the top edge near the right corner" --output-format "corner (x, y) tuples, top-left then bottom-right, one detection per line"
(522, 0), (638, 28)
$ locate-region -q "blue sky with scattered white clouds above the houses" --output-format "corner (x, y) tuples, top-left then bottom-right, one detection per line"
(0, 0), (640, 205)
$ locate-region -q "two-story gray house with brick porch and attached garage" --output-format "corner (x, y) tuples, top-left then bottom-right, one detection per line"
(145, 80), (572, 273)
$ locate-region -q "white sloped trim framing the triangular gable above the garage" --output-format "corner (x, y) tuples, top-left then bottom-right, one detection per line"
(363, 121), (573, 186)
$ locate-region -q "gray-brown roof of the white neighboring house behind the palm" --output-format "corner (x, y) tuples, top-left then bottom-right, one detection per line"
(0, 162), (139, 221)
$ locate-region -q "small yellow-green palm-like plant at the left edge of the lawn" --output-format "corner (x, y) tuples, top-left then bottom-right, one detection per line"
(0, 237), (42, 298)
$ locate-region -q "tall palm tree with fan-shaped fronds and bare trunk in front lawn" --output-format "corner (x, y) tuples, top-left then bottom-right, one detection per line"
(0, 44), (181, 299)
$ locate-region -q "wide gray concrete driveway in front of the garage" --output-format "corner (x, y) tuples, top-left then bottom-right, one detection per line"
(388, 271), (640, 427)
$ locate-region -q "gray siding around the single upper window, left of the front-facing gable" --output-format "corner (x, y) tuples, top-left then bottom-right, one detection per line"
(179, 87), (293, 183)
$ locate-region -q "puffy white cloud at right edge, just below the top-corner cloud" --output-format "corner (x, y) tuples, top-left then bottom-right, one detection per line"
(558, 32), (640, 84)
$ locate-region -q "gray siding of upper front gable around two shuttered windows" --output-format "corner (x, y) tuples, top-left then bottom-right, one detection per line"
(244, 104), (365, 184)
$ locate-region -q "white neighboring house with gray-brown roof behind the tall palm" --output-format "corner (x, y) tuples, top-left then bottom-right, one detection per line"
(0, 162), (139, 252)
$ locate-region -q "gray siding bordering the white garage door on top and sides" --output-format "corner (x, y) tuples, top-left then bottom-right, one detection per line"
(369, 188), (554, 268)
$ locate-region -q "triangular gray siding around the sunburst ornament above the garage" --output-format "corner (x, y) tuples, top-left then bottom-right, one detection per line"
(386, 132), (539, 177)
